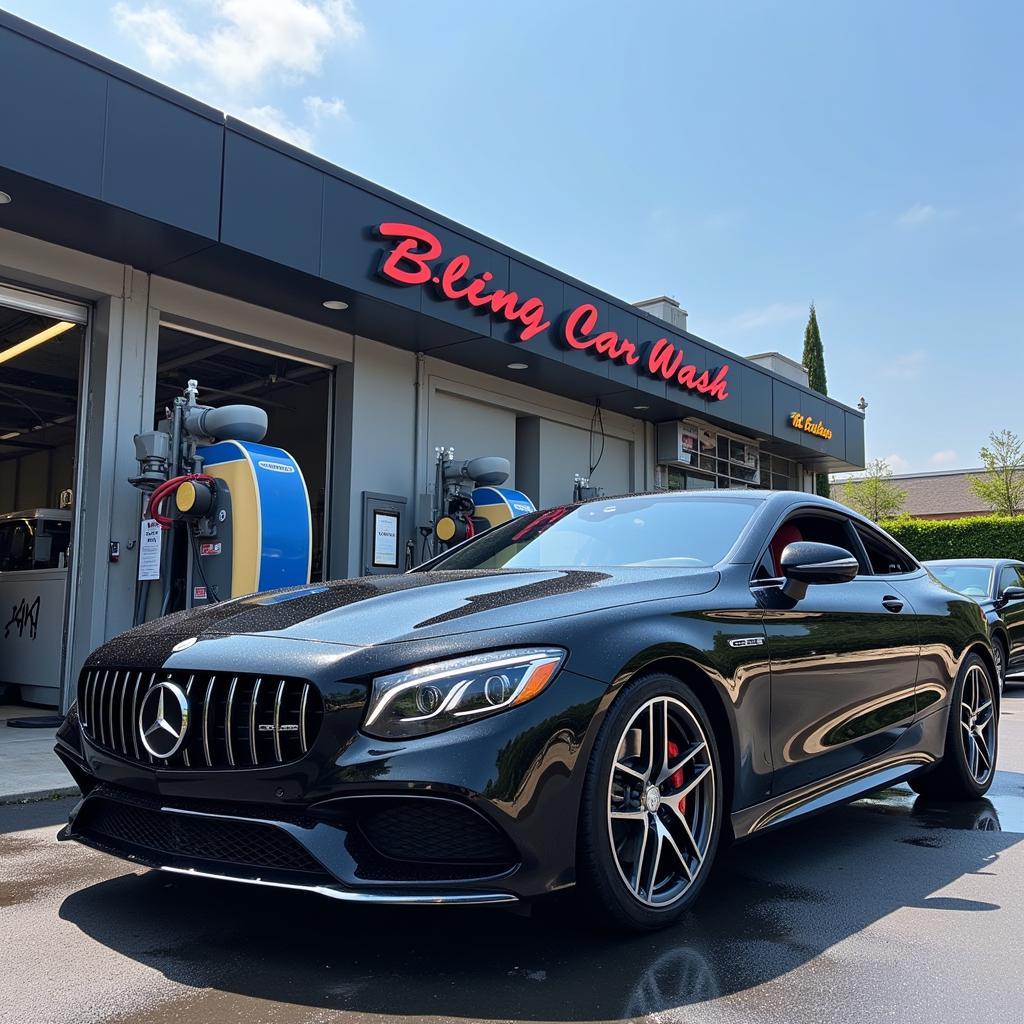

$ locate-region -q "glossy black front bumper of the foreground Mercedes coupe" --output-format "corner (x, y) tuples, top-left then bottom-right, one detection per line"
(56, 638), (607, 903)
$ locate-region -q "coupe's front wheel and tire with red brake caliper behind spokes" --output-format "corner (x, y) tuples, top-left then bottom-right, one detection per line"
(578, 673), (725, 931)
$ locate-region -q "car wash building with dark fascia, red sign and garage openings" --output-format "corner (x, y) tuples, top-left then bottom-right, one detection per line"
(0, 13), (864, 705)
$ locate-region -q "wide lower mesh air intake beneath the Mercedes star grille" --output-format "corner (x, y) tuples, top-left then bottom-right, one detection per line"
(75, 797), (333, 881)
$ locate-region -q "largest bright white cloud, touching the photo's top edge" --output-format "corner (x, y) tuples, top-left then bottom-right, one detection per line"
(114, 0), (362, 94)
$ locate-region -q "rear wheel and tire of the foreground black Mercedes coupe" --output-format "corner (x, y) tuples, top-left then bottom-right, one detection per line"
(909, 654), (998, 800)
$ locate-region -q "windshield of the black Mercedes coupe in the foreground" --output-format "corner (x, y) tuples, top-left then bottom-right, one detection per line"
(425, 495), (759, 569)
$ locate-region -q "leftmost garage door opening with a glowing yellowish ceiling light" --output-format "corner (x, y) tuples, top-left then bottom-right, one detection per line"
(0, 287), (87, 708)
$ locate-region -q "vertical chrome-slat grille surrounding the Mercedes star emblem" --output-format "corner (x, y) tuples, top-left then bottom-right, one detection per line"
(78, 669), (324, 770)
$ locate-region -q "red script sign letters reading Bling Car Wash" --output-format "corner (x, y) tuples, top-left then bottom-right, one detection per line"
(378, 222), (729, 400)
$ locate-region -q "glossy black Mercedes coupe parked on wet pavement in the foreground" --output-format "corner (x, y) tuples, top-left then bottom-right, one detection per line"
(56, 490), (998, 929)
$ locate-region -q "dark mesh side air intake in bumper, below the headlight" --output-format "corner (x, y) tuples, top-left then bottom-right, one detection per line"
(358, 797), (515, 865)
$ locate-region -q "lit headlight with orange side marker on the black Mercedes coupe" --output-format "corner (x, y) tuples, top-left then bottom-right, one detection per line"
(362, 647), (565, 739)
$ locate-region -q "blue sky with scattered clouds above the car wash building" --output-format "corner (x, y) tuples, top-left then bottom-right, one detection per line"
(5, 0), (1024, 472)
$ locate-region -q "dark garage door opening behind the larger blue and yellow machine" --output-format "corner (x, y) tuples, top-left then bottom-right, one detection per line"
(154, 324), (333, 598)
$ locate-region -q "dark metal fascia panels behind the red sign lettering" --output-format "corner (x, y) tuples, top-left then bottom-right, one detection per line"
(0, 12), (864, 470)
